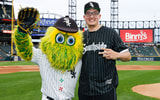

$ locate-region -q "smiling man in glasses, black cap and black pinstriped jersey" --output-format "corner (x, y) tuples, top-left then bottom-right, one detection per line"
(78, 2), (131, 100)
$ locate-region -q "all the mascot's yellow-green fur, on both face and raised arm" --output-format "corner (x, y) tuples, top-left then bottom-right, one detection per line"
(14, 27), (83, 72)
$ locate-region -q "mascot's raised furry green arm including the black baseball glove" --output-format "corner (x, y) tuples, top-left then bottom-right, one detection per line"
(14, 8), (39, 61)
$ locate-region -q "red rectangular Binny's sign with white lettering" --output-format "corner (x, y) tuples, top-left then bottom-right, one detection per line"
(120, 29), (153, 43)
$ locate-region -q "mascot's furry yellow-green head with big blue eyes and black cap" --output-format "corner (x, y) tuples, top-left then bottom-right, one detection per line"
(40, 16), (83, 72)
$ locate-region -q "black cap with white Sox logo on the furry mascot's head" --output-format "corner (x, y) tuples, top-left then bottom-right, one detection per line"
(53, 15), (78, 33)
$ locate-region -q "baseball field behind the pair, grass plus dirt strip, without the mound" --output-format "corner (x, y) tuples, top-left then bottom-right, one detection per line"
(0, 61), (160, 100)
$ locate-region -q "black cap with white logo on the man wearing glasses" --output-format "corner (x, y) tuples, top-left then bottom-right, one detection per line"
(84, 1), (100, 13)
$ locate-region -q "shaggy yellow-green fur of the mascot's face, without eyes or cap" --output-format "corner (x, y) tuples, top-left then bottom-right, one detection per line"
(40, 27), (83, 71)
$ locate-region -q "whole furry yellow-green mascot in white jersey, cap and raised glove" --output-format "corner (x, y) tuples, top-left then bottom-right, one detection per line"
(14, 8), (83, 100)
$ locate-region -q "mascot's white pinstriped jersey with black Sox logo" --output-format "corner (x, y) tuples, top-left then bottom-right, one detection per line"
(31, 47), (82, 100)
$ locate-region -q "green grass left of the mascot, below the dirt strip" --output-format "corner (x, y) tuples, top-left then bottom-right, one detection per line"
(0, 72), (41, 100)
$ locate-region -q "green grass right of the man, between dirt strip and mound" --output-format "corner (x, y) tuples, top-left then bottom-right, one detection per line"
(117, 70), (160, 100)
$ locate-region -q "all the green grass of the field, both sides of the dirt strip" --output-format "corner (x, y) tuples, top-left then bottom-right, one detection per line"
(0, 61), (160, 100)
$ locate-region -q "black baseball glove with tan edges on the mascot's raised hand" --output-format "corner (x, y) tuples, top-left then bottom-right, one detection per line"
(17, 7), (40, 33)
